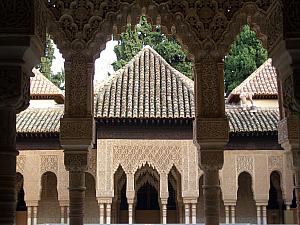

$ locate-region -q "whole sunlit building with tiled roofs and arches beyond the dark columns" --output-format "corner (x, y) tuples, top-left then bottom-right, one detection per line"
(17, 47), (296, 225)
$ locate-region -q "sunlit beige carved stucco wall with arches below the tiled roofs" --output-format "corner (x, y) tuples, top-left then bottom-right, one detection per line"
(17, 145), (293, 223)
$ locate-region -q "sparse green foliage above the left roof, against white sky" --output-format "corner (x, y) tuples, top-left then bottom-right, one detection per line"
(36, 34), (65, 89)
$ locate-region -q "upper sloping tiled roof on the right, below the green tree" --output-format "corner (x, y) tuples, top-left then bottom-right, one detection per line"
(228, 59), (278, 102)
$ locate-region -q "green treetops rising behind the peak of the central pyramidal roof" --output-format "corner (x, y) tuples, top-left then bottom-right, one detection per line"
(112, 16), (192, 78)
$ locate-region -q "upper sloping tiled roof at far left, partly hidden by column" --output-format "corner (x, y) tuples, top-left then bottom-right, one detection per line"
(30, 68), (64, 103)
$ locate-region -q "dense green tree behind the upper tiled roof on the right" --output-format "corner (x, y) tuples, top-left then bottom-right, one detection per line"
(224, 25), (268, 94)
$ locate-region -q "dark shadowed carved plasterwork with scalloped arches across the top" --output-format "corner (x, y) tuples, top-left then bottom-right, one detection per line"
(48, 0), (273, 59)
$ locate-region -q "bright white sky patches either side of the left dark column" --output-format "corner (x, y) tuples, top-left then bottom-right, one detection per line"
(51, 40), (118, 81)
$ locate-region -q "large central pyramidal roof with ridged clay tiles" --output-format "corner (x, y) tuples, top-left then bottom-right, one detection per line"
(95, 47), (194, 118)
